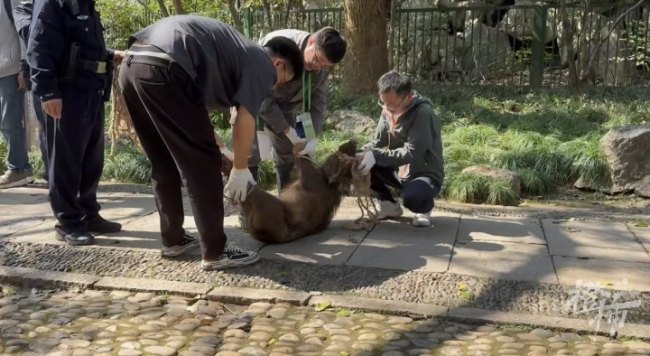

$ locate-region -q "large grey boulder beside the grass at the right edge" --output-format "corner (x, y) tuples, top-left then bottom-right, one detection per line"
(600, 125), (650, 198)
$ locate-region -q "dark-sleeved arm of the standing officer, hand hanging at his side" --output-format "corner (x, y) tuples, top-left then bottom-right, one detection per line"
(27, 0), (68, 104)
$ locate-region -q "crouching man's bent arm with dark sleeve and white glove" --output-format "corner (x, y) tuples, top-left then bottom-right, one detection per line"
(372, 105), (434, 167)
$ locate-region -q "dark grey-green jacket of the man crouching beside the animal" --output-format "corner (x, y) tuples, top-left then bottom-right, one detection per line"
(366, 93), (445, 188)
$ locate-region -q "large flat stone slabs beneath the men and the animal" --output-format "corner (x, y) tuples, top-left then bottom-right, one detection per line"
(0, 188), (650, 291)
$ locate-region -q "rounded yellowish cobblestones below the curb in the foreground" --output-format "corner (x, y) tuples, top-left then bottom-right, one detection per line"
(0, 287), (650, 356)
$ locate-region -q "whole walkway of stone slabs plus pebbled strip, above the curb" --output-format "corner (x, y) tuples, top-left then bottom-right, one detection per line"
(0, 188), (650, 335)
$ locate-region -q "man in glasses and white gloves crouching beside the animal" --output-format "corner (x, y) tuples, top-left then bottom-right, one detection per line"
(357, 71), (445, 226)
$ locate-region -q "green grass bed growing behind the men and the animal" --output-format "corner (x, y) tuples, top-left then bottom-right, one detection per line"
(83, 84), (650, 205)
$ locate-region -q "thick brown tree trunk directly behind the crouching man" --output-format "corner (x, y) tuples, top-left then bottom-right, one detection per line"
(343, 0), (388, 95)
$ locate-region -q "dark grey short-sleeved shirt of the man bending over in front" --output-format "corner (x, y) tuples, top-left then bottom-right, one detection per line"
(130, 15), (277, 117)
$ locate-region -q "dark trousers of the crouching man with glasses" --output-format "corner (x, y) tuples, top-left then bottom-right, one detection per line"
(370, 166), (440, 214)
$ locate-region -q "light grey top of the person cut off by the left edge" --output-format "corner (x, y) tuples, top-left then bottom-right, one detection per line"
(0, 0), (25, 78)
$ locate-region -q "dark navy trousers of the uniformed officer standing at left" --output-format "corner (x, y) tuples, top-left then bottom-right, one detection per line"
(45, 86), (104, 232)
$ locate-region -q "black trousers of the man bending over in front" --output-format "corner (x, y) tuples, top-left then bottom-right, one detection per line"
(119, 56), (226, 260)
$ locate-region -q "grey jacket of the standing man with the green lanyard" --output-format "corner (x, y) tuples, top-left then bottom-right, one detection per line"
(259, 30), (329, 134)
